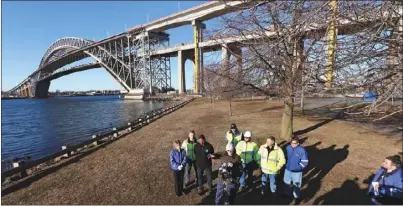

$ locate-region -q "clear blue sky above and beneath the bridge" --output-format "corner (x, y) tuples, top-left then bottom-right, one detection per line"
(1, 1), (224, 91)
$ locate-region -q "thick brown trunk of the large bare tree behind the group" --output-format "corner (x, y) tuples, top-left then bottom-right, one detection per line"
(281, 95), (294, 141)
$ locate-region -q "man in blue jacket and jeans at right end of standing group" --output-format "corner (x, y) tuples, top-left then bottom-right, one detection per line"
(284, 136), (308, 201)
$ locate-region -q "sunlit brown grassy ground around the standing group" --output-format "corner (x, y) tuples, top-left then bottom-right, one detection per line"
(1, 98), (402, 204)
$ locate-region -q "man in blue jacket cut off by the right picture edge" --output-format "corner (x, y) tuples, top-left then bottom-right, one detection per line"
(368, 155), (403, 205)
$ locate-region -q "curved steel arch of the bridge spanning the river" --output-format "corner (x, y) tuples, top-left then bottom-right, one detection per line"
(32, 35), (133, 97)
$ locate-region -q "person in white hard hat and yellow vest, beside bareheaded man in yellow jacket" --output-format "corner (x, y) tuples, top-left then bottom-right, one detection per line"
(236, 131), (258, 191)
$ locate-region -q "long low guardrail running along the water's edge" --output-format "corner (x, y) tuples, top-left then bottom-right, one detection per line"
(1, 97), (195, 183)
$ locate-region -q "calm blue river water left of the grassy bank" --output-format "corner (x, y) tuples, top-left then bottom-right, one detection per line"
(1, 96), (163, 160)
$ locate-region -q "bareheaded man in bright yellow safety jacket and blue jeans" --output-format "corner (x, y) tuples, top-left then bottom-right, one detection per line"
(256, 136), (285, 197)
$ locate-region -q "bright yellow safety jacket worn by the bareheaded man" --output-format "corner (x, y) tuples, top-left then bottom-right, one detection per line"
(256, 144), (285, 174)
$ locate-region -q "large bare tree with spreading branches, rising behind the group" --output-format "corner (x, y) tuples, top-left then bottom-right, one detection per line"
(204, 0), (402, 139)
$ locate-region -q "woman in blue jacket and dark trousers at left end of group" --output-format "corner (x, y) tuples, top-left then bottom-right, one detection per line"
(169, 140), (186, 196)
